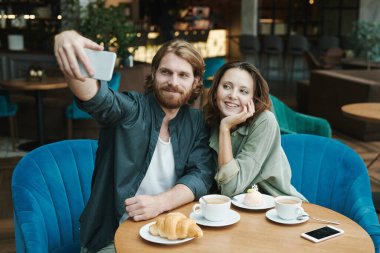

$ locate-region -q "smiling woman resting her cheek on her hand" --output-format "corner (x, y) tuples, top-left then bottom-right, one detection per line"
(205, 62), (306, 200)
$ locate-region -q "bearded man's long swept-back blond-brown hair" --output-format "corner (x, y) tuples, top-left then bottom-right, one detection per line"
(145, 40), (205, 103)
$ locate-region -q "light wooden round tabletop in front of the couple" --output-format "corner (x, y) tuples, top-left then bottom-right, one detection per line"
(115, 202), (375, 253)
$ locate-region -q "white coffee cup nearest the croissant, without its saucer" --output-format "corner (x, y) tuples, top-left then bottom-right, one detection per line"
(193, 194), (231, 221)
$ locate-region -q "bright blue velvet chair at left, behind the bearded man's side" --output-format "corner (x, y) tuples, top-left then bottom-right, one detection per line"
(12, 140), (97, 253)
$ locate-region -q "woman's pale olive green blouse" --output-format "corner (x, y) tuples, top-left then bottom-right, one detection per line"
(210, 111), (306, 200)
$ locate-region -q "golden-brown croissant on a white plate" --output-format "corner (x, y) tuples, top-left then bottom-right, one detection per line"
(149, 213), (203, 240)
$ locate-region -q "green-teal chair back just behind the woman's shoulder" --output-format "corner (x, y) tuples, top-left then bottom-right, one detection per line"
(270, 95), (332, 138)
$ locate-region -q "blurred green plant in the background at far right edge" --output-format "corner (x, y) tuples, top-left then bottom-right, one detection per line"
(351, 21), (380, 69)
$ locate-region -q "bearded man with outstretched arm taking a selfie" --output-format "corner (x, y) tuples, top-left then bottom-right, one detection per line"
(54, 31), (214, 252)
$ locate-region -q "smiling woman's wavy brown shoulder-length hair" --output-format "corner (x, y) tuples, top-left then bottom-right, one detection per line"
(204, 61), (272, 127)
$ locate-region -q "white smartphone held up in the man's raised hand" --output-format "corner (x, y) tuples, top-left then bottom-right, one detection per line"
(79, 48), (116, 81)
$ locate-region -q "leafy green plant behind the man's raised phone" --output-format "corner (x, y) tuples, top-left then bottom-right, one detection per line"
(79, 0), (136, 66)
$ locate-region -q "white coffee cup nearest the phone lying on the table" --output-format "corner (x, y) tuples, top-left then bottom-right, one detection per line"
(274, 196), (305, 220)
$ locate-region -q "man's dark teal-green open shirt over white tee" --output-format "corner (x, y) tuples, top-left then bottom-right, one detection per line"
(78, 82), (214, 251)
